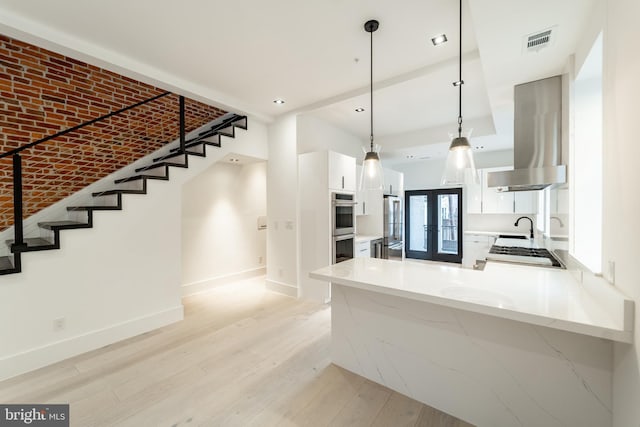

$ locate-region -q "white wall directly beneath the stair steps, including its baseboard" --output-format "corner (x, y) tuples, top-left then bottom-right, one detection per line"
(0, 118), (267, 379)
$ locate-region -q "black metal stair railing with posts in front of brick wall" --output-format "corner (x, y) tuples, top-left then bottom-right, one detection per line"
(0, 92), (186, 271)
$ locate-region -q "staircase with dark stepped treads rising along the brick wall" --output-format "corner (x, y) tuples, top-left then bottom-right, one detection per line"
(0, 98), (247, 275)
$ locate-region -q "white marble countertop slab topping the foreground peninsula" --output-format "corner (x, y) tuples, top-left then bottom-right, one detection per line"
(309, 258), (634, 342)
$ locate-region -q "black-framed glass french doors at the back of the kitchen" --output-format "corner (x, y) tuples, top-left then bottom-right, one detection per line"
(404, 188), (462, 263)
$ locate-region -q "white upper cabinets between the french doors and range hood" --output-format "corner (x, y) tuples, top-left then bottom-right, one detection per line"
(466, 167), (538, 214)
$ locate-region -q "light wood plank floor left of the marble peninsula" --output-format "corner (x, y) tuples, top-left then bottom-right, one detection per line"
(0, 278), (469, 427)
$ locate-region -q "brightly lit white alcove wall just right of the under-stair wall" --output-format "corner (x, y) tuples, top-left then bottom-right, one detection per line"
(182, 159), (267, 294)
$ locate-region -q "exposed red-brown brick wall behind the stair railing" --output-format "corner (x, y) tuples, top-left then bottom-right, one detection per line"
(0, 35), (225, 230)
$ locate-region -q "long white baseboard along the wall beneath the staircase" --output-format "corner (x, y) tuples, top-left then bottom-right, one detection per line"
(0, 305), (184, 381)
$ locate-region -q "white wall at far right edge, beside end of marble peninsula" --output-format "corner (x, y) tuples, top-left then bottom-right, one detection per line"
(598, 0), (640, 427)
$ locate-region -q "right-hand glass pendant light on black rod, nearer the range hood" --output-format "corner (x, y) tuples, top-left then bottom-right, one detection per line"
(441, 0), (478, 185)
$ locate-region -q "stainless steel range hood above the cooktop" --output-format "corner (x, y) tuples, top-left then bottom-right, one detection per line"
(487, 76), (567, 191)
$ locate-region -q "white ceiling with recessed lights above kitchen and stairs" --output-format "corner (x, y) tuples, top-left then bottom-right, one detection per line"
(0, 0), (596, 167)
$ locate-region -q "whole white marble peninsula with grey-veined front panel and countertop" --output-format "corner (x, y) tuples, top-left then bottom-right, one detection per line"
(310, 258), (633, 427)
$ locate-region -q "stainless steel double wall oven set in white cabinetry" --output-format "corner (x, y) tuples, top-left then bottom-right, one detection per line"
(331, 193), (356, 264)
